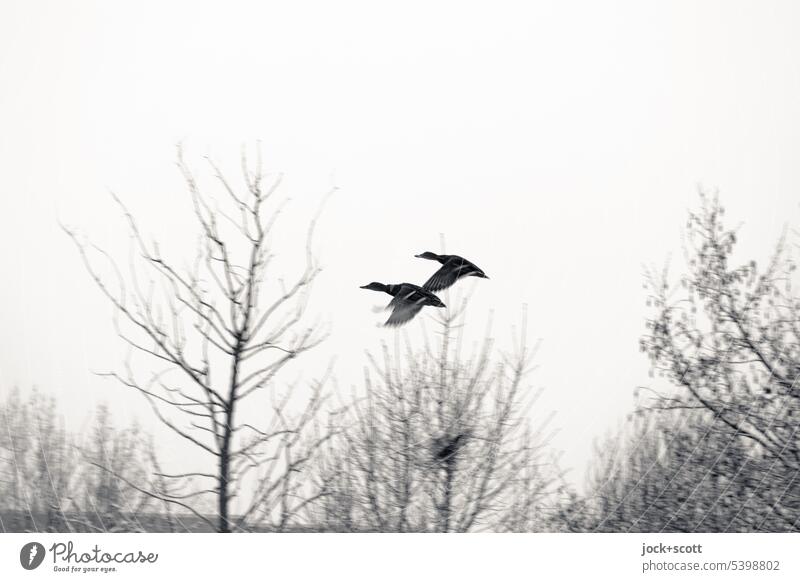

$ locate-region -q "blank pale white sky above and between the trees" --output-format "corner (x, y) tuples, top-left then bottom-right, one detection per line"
(0, 0), (800, 490)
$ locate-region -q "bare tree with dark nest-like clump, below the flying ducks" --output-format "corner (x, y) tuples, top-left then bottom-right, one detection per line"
(314, 306), (556, 532)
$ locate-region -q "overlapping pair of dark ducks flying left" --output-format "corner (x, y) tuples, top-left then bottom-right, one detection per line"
(361, 252), (489, 326)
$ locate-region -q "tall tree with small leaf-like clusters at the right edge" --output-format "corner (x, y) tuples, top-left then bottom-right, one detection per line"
(641, 195), (800, 530)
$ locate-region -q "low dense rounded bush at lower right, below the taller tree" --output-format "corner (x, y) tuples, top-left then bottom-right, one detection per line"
(571, 410), (785, 532)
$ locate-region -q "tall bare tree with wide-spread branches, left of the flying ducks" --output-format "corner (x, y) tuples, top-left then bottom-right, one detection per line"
(65, 148), (328, 532)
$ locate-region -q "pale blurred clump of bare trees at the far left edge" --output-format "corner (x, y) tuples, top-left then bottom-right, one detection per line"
(0, 390), (161, 532)
